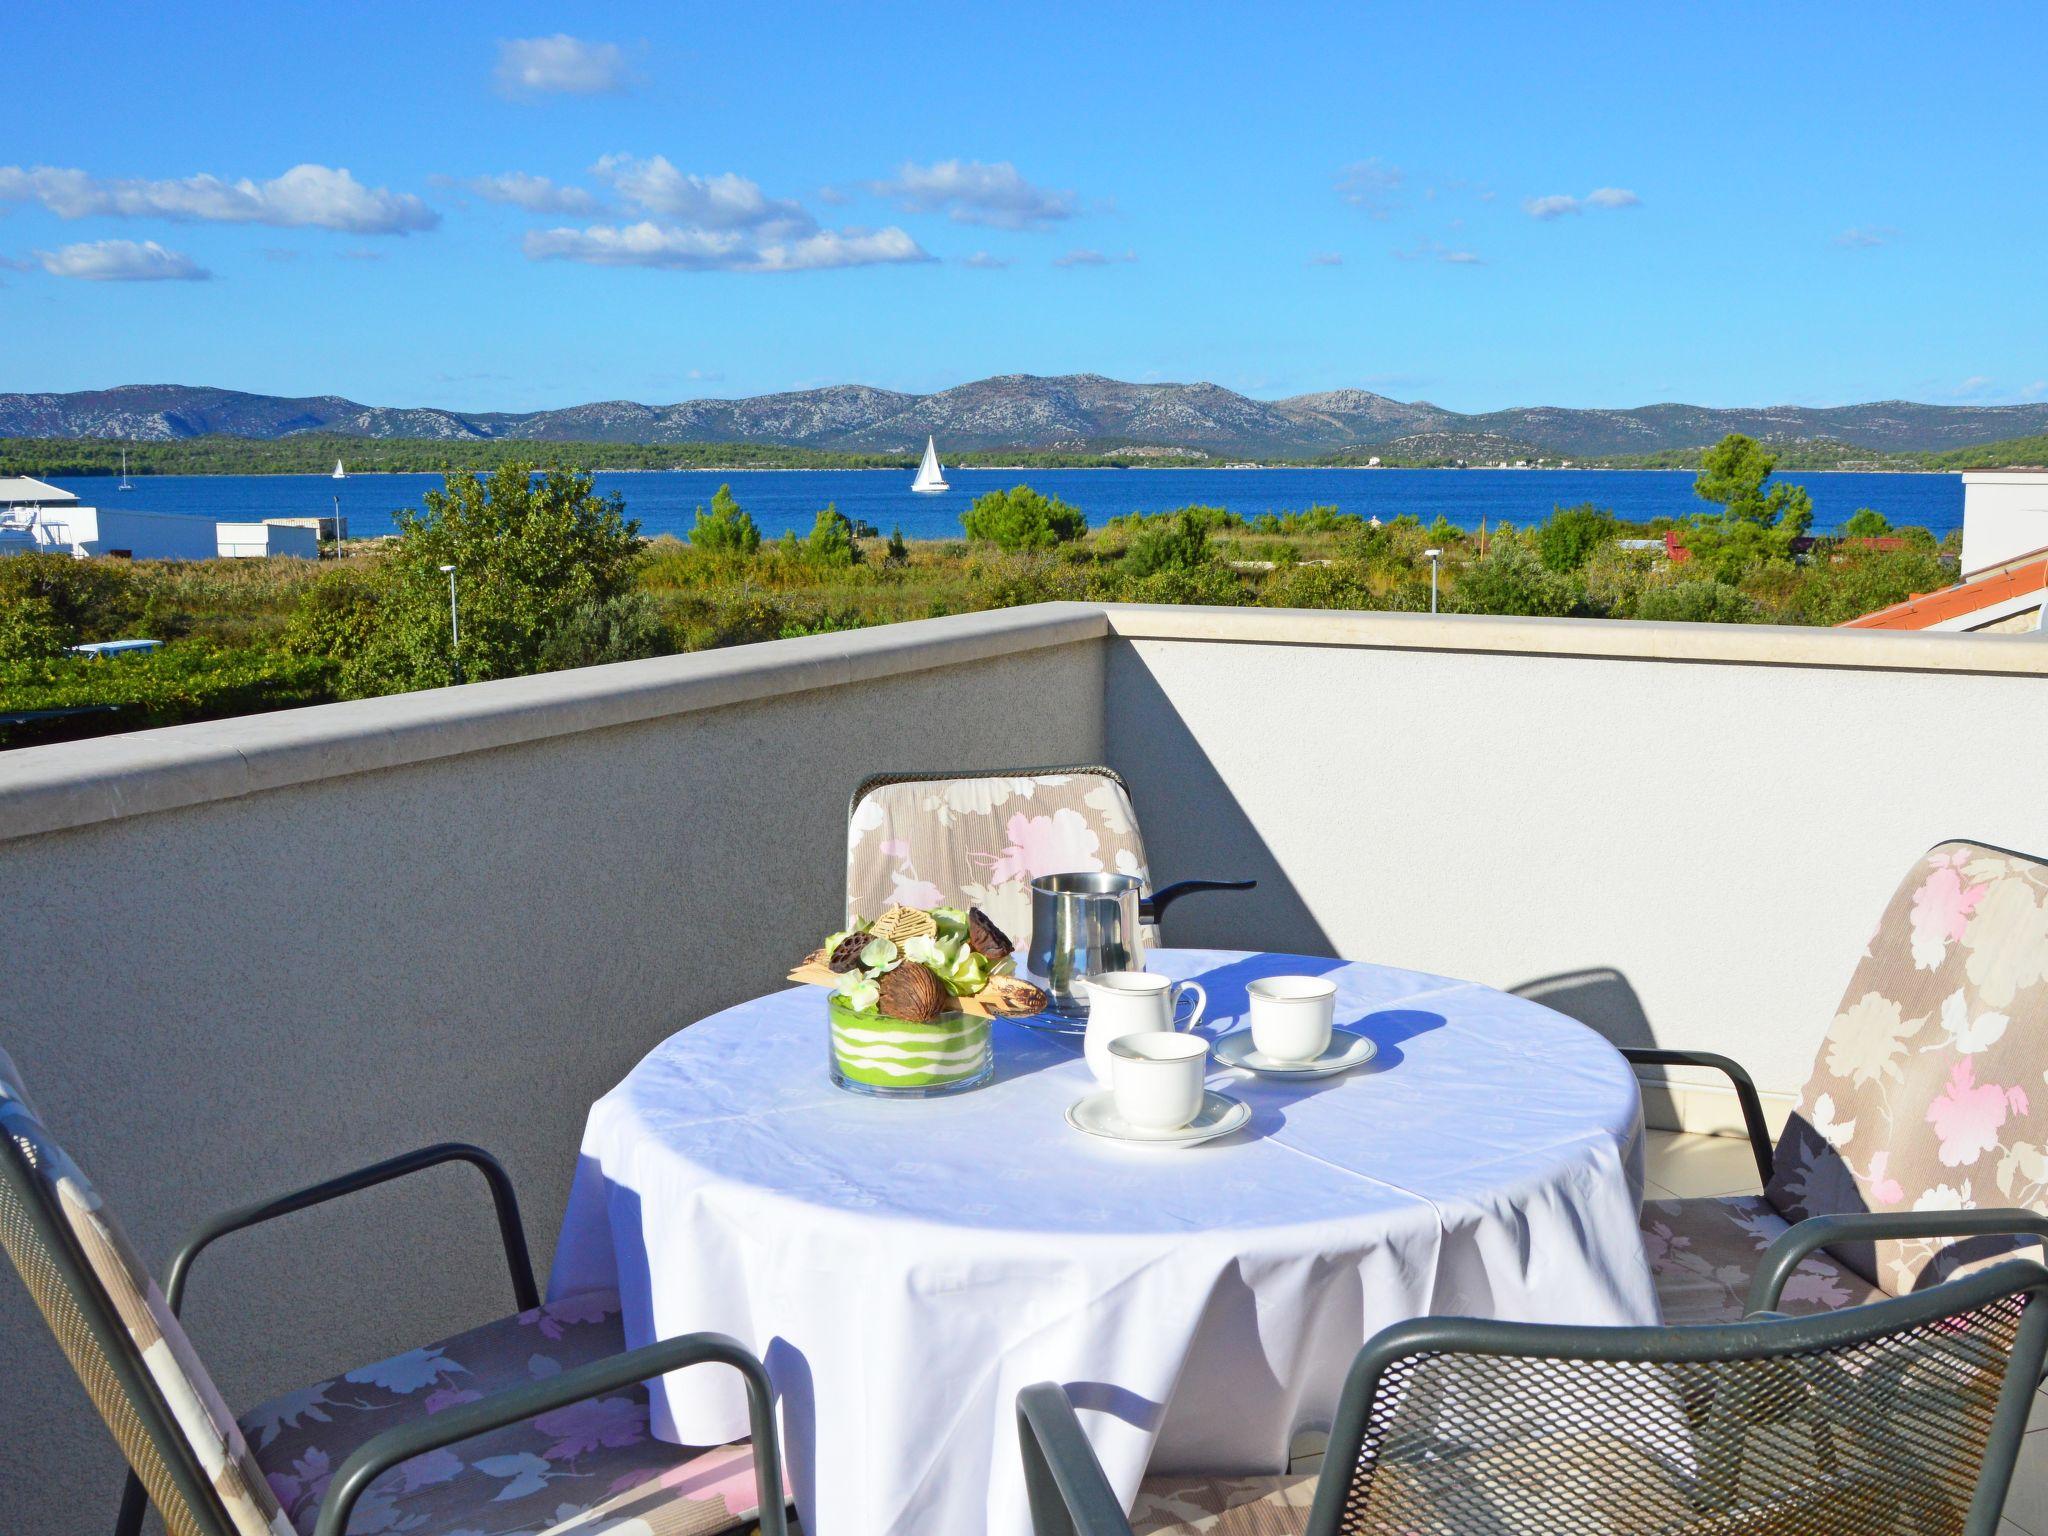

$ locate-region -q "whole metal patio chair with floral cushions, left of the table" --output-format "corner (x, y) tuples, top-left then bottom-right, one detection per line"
(0, 1051), (786, 1536)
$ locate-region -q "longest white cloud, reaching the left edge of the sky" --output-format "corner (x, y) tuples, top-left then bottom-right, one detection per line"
(0, 166), (440, 236)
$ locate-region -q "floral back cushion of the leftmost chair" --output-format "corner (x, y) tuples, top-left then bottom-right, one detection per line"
(0, 1055), (291, 1536)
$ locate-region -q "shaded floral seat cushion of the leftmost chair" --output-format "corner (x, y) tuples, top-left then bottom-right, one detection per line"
(242, 1290), (760, 1536)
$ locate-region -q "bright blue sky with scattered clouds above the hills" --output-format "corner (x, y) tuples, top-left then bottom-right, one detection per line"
(0, 0), (2048, 410)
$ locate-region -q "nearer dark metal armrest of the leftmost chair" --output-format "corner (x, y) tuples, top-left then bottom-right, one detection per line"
(313, 1333), (788, 1536)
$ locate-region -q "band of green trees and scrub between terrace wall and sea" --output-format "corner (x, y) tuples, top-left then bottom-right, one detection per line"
(0, 442), (1954, 745)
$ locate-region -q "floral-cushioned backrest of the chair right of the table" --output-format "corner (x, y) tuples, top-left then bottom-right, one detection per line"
(1765, 842), (2048, 1294)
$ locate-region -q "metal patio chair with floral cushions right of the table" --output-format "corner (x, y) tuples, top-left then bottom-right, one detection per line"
(1622, 842), (2048, 1323)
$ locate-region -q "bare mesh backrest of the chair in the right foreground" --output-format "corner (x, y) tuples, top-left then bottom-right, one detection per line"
(1309, 1260), (2048, 1536)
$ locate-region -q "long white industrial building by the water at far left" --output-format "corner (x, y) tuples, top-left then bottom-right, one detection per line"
(0, 475), (324, 559)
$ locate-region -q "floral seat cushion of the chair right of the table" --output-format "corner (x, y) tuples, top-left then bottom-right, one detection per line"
(1642, 1194), (1882, 1327)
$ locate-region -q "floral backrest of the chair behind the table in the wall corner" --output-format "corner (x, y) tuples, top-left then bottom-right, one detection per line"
(846, 766), (1151, 948)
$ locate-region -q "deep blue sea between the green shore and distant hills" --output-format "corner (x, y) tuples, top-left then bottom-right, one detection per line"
(53, 469), (1962, 539)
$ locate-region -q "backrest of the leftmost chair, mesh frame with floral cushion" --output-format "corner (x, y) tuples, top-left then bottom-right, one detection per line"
(0, 1051), (293, 1536)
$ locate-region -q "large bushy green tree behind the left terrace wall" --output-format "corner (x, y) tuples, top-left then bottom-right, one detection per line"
(342, 465), (639, 696)
